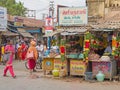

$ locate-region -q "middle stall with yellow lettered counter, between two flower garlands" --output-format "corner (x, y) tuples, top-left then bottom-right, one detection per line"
(58, 26), (89, 76)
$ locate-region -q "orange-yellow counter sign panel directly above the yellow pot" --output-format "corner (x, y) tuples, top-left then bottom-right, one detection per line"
(54, 59), (67, 69)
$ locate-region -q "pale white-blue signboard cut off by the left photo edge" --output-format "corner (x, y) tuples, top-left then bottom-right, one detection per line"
(0, 7), (7, 31)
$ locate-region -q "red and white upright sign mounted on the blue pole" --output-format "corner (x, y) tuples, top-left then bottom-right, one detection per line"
(45, 17), (53, 34)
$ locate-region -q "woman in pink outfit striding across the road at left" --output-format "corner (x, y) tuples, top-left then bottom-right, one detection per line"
(3, 40), (16, 78)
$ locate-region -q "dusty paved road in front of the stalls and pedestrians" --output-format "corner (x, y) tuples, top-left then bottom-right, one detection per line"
(0, 62), (120, 90)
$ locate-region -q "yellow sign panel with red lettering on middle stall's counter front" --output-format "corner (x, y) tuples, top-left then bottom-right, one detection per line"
(70, 60), (86, 75)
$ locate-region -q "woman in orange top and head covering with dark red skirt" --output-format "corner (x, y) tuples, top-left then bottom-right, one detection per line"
(27, 41), (38, 74)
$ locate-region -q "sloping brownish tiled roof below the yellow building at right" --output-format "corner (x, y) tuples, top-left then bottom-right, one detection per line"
(91, 11), (120, 31)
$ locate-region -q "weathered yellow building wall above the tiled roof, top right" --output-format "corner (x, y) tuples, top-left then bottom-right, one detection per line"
(87, 0), (120, 17)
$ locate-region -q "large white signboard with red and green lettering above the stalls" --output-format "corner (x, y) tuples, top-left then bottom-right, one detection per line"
(58, 7), (88, 26)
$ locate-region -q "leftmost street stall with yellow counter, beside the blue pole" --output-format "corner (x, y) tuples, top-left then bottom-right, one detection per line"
(43, 30), (67, 75)
